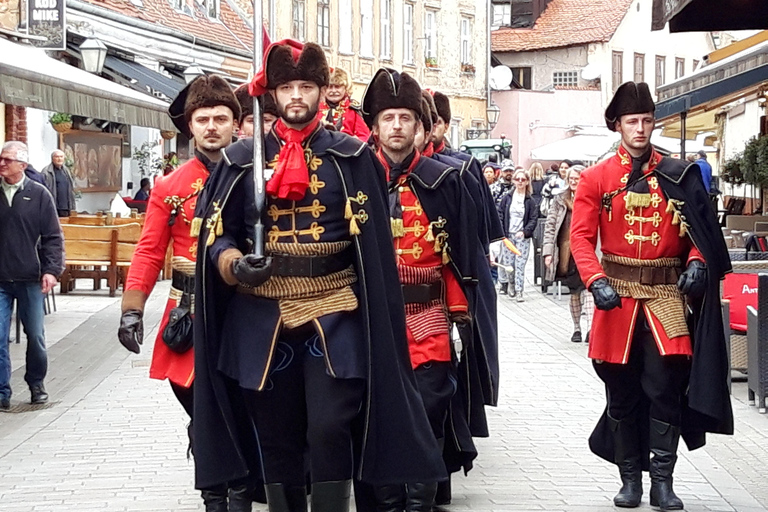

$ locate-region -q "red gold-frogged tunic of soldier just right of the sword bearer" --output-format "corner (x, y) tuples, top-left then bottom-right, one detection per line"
(379, 154), (468, 368)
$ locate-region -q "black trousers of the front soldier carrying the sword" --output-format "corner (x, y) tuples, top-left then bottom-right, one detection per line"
(243, 328), (365, 486)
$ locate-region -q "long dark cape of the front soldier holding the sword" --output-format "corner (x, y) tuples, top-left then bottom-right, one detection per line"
(194, 128), (447, 488)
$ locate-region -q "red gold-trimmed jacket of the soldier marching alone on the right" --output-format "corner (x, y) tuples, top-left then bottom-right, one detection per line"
(571, 146), (703, 364)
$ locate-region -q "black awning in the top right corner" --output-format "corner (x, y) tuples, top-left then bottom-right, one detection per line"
(651, 0), (768, 32)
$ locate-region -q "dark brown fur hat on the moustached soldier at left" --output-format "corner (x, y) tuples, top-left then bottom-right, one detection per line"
(168, 75), (240, 137)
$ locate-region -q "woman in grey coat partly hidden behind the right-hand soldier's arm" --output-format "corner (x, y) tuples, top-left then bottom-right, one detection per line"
(541, 165), (592, 343)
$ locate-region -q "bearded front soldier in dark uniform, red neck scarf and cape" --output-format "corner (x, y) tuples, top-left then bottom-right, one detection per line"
(195, 40), (445, 512)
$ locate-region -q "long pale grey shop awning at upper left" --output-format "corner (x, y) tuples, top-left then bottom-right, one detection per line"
(0, 38), (174, 130)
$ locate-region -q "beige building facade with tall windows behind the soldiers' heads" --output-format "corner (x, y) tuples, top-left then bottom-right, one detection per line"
(264, 0), (488, 144)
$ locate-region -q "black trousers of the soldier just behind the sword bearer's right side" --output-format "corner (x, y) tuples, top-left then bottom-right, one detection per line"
(413, 361), (456, 439)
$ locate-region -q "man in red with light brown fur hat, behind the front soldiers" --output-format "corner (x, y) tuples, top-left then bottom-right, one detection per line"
(317, 68), (371, 142)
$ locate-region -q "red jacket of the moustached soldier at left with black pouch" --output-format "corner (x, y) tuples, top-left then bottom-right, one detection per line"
(125, 158), (208, 387)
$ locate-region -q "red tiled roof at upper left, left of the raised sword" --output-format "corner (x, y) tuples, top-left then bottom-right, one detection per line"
(83, 0), (253, 51)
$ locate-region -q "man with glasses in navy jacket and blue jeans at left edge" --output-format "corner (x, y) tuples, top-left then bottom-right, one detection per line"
(0, 141), (64, 411)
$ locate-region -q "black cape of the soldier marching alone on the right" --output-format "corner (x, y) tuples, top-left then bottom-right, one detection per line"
(589, 157), (733, 469)
